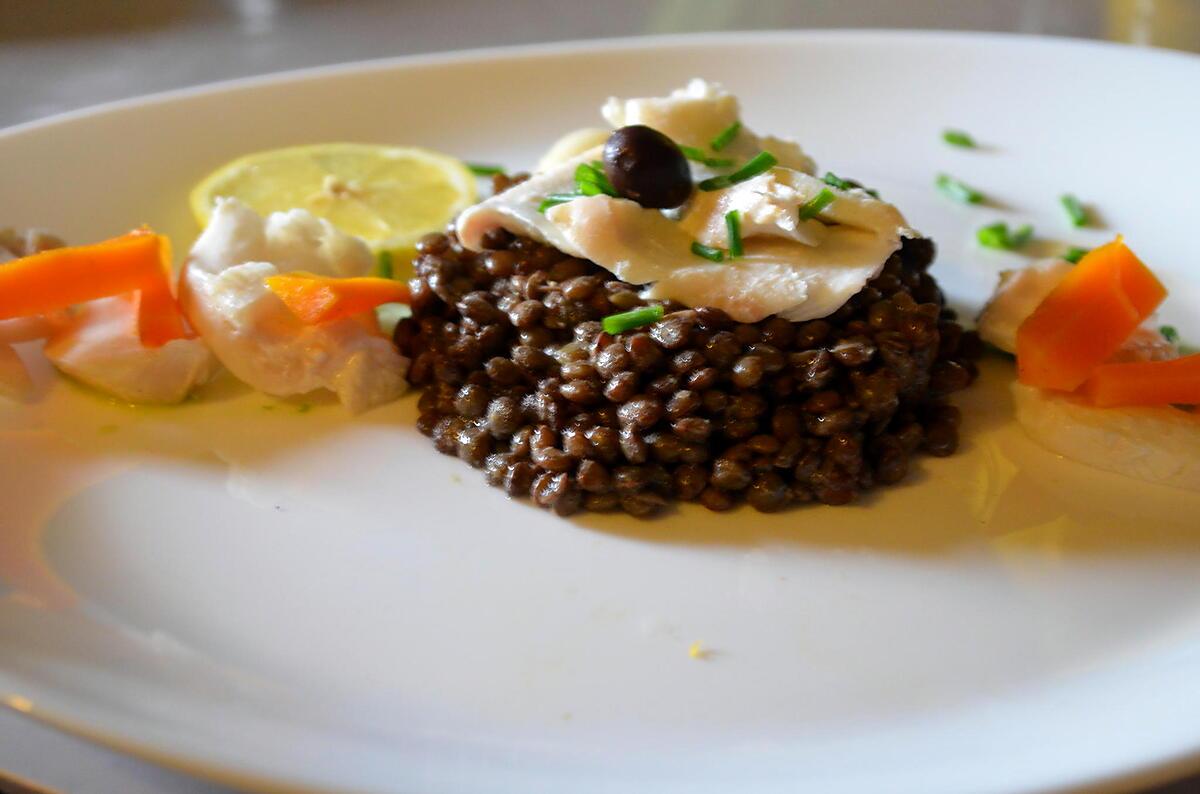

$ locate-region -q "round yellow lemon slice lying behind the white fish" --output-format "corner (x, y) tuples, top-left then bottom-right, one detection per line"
(191, 144), (476, 252)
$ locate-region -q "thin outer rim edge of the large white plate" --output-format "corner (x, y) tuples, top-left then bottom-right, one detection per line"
(7, 28), (1200, 792)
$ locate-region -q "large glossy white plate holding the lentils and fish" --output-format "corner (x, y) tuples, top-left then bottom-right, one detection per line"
(0, 32), (1200, 794)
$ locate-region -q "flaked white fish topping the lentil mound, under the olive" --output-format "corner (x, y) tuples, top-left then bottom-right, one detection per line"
(457, 80), (917, 321)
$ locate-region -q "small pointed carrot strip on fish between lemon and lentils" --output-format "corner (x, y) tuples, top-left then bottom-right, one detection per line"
(266, 272), (412, 325)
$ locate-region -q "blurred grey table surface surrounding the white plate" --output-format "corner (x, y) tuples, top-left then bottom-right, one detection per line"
(0, 0), (1200, 794)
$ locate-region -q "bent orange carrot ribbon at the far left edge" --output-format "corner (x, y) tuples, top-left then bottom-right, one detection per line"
(0, 230), (187, 347)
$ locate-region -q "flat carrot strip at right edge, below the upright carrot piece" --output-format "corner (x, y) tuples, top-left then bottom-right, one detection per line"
(1082, 354), (1200, 408)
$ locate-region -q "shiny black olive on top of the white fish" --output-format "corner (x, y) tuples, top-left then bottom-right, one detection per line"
(604, 124), (691, 210)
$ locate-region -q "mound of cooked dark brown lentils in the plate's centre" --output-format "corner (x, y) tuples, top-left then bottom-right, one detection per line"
(395, 225), (980, 516)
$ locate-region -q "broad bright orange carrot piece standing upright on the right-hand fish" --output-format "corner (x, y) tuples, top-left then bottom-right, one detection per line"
(1016, 237), (1166, 391)
